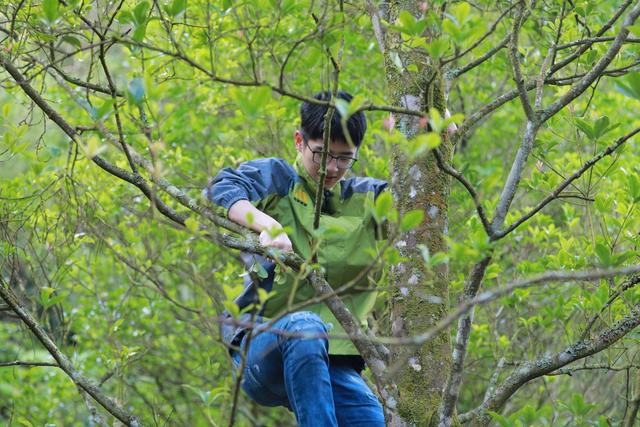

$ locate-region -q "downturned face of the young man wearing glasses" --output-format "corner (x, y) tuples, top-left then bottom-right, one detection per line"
(294, 131), (358, 189)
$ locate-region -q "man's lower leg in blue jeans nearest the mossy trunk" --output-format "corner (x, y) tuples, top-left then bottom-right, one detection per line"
(329, 365), (385, 427)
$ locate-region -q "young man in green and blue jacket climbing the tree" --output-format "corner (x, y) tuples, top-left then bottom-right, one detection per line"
(205, 92), (387, 427)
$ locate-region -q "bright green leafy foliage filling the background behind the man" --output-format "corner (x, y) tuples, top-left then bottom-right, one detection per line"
(0, 0), (640, 426)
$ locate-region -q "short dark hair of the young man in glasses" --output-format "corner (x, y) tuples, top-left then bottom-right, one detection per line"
(300, 90), (367, 147)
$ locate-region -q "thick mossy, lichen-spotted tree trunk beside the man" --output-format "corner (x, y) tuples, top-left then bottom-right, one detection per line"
(384, 1), (453, 426)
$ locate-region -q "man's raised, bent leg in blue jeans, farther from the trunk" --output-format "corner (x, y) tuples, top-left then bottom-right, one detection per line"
(232, 311), (338, 427)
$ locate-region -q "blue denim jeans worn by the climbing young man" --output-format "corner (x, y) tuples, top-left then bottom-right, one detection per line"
(232, 311), (385, 427)
